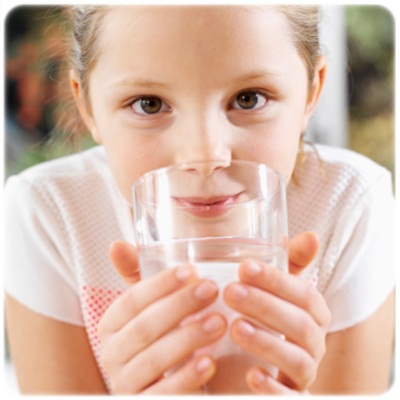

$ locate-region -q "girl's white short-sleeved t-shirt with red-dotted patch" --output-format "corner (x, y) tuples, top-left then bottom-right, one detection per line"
(4, 145), (395, 376)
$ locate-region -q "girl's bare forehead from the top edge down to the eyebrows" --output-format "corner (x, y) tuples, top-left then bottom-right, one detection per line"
(87, 6), (306, 94)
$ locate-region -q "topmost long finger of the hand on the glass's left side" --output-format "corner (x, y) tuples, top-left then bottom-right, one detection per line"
(98, 265), (198, 340)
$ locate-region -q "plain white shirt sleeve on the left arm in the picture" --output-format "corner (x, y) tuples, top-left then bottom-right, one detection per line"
(4, 176), (83, 326)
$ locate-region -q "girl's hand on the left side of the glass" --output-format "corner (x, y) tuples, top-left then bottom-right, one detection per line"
(98, 262), (226, 394)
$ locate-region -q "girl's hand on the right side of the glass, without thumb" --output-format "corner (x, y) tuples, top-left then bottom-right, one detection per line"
(224, 260), (330, 395)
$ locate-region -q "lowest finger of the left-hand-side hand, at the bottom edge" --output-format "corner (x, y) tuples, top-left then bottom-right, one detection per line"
(141, 355), (216, 395)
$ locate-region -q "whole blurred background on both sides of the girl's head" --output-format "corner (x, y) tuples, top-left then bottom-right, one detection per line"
(4, 5), (395, 184)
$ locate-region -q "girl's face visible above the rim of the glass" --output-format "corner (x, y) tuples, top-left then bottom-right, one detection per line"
(72, 6), (325, 201)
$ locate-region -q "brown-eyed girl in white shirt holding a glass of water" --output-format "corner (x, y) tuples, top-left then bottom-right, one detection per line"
(6, 6), (394, 394)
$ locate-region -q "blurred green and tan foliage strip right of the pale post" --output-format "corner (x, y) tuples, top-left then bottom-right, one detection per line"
(346, 6), (395, 180)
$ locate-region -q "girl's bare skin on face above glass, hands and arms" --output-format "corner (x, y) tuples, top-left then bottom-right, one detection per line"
(7, 7), (393, 394)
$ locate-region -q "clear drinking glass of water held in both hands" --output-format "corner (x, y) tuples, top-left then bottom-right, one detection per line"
(133, 161), (287, 393)
